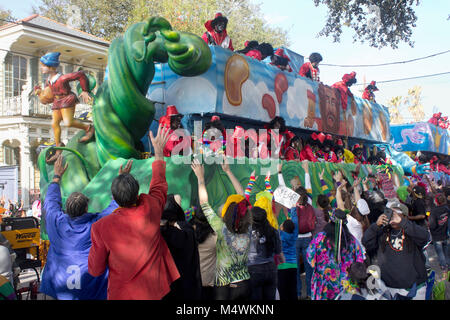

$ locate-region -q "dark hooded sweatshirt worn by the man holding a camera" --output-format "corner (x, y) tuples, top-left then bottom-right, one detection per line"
(362, 217), (428, 289)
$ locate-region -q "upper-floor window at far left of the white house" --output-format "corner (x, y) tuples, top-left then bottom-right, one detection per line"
(5, 53), (28, 97)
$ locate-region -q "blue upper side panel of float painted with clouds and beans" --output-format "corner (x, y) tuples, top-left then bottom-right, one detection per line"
(147, 46), (390, 142)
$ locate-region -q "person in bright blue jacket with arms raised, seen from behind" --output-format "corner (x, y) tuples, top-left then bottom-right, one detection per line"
(40, 155), (125, 300)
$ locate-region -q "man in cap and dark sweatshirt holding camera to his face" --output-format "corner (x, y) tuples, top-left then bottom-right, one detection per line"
(362, 200), (429, 300)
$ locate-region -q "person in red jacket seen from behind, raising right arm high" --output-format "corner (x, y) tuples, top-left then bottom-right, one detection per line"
(88, 124), (180, 300)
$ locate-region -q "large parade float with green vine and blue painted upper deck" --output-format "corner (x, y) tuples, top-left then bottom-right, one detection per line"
(38, 18), (426, 239)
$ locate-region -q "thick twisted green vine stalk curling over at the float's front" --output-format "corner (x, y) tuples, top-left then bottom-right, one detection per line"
(93, 18), (211, 165)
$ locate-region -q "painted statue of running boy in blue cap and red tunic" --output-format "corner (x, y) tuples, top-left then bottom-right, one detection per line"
(34, 52), (94, 163)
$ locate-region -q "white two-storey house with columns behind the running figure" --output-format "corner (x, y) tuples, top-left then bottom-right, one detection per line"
(0, 14), (109, 207)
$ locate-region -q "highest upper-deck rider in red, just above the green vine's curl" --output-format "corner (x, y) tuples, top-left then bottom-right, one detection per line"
(202, 12), (234, 51)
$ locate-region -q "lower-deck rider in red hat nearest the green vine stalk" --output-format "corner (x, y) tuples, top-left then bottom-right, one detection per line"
(159, 105), (191, 157)
